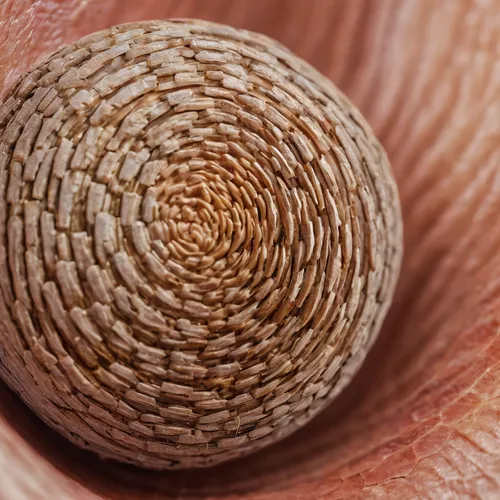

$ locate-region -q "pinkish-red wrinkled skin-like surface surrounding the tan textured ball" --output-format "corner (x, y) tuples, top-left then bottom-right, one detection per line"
(0, 0), (500, 500)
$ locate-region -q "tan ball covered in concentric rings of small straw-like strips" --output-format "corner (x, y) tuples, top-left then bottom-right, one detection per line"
(0, 20), (402, 469)
